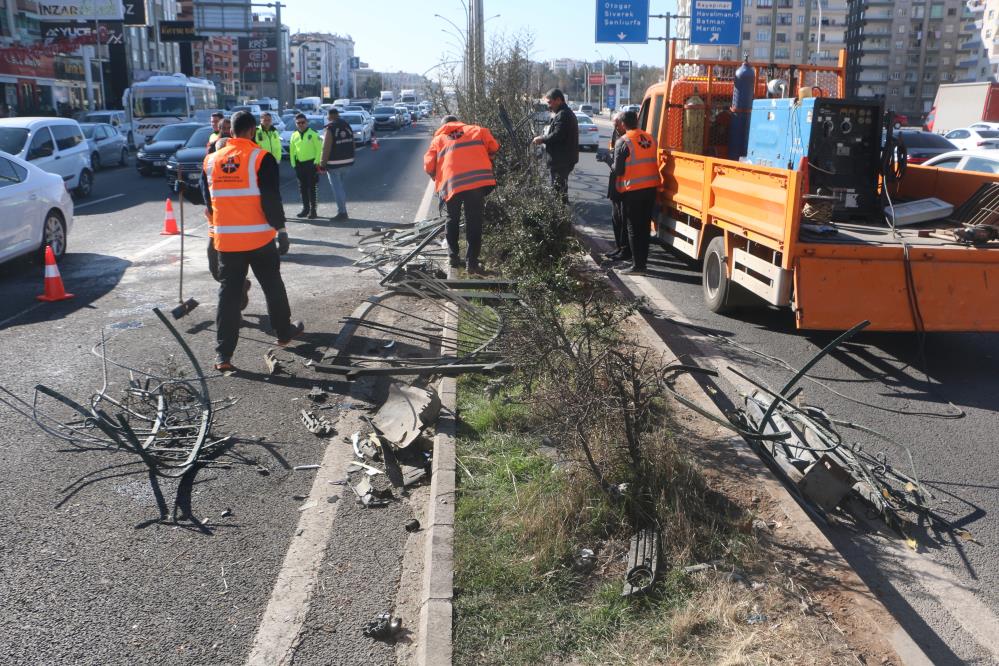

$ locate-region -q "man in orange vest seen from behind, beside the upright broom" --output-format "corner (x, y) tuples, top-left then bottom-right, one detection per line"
(201, 111), (305, 372)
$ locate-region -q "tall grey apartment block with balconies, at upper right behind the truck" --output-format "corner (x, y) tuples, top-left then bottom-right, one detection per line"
(847, 0), (999, 123)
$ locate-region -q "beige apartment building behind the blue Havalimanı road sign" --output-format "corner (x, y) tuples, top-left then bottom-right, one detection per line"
(676, 0), (848, 65)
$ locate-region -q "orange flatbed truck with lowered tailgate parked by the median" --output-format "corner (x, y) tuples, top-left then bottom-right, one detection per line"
(640, 43), (999, 331)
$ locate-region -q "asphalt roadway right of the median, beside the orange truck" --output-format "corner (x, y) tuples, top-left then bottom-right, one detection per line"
(570, 116), (999, 664)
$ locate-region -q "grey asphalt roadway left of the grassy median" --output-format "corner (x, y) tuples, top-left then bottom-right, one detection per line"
(0, 122), (438, 666)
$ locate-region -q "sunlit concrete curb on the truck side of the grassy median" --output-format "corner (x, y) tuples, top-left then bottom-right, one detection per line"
(574, 223), (932, 666)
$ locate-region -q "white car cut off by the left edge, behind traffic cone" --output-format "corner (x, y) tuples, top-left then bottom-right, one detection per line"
(0, 152), (73, 261)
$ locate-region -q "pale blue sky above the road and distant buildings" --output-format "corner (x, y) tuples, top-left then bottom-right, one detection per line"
(281, 0), (676, 77)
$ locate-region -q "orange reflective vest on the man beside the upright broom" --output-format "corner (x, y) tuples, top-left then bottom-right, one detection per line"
(205, 138), (277, 252)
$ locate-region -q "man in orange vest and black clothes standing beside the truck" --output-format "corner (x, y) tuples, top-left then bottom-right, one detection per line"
(611, 111), (662, 275)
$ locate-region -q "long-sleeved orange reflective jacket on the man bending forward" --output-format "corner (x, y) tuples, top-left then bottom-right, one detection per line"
(423, 122), (499, 201)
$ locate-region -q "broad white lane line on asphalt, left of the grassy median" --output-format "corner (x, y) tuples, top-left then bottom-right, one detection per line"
(246, 440), (354, 666)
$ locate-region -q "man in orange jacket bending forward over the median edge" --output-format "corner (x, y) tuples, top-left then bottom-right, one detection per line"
(423, 116), (500, 273)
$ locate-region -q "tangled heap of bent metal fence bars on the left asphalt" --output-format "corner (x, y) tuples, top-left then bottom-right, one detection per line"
(0, 309), (236, 477)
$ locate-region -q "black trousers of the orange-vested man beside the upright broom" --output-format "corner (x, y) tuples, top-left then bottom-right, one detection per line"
(215, 241), (291, 361)
